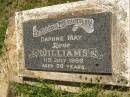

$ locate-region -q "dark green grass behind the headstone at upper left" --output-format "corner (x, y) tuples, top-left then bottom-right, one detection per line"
(0, 0), (79, 55)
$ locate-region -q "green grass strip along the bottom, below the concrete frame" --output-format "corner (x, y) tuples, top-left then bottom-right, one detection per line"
(11, 82), (130, 97)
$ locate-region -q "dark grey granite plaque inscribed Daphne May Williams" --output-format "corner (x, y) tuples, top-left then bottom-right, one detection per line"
(23, 12), (112, 74)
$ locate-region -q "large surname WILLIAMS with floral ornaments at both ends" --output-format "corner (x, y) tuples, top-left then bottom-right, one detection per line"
(29, 48), (103, 59)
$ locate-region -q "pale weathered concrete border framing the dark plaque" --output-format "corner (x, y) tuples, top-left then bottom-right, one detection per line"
(16, 0), (130, 86)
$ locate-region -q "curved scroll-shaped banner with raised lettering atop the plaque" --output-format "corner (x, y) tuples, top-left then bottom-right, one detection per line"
(33, 18), (94, 37)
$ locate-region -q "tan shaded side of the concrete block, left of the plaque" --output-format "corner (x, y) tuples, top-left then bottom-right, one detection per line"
(0, 17), (19, 97)
